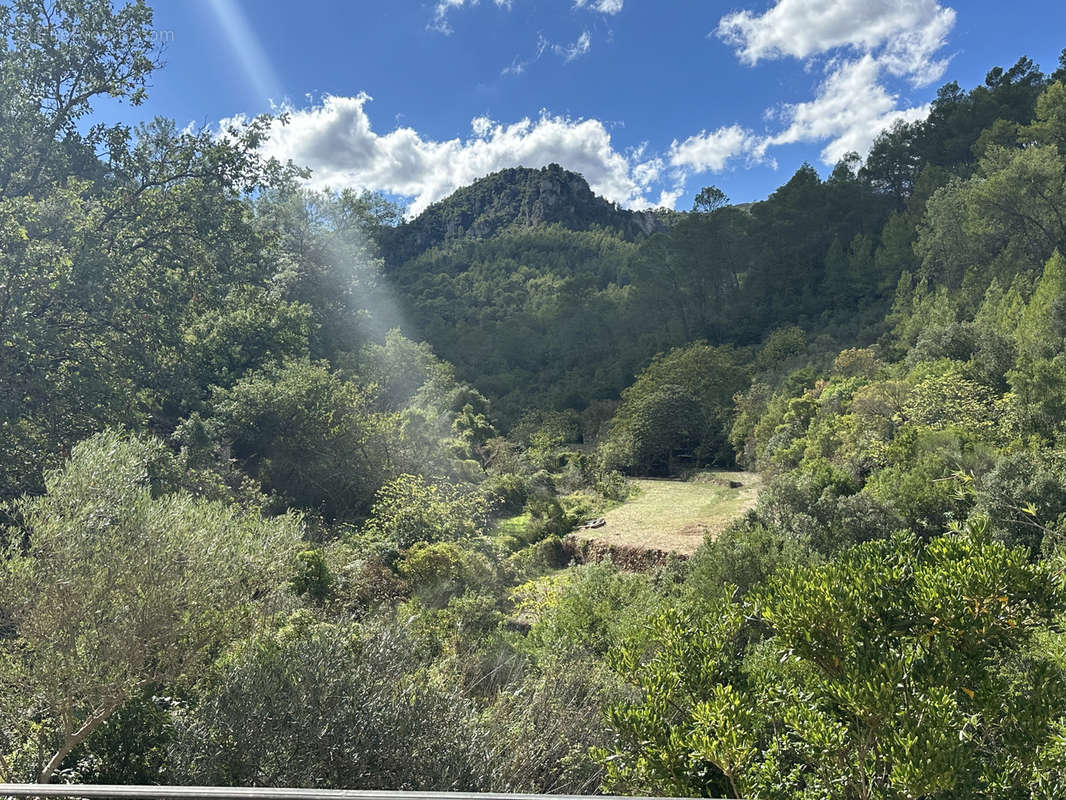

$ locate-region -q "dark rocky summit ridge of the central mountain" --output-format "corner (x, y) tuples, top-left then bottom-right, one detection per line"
(382, 164), (666, 267)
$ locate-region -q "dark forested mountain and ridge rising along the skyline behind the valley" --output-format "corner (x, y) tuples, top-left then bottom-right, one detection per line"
(378, 59), (1054, 422)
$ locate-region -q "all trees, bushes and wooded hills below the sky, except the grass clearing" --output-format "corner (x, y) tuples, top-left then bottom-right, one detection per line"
(6, 0), (1066, 798)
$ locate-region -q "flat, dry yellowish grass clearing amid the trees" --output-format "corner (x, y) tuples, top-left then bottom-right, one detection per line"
(578, 473), (761, 556)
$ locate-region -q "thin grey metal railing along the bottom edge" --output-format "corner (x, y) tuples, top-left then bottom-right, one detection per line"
(0, 783), (707, 800)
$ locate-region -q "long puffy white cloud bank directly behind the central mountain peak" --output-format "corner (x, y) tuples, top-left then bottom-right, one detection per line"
(245, 94), (663, 214)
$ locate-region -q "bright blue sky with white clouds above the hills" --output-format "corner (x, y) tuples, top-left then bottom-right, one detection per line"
(118, 0), (1066, 212)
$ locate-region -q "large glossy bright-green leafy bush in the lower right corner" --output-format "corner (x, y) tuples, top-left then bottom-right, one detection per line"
(599, 524), (1066, 800)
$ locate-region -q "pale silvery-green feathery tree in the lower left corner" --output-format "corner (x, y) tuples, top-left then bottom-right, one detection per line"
(0, 432), (301, 783)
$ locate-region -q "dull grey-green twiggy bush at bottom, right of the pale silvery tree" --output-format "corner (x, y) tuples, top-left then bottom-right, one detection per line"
(171, 617), (486, 790)
